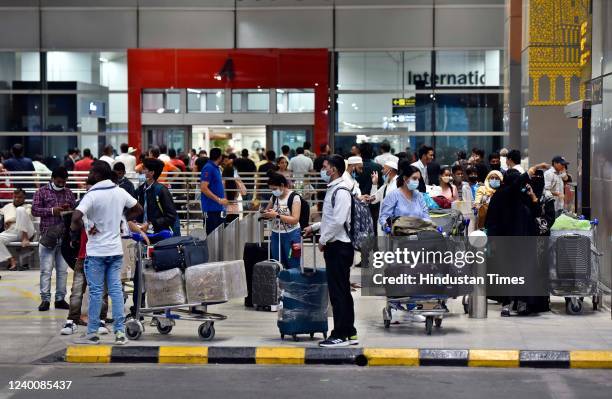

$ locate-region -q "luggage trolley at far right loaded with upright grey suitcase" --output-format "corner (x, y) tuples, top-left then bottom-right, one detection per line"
(549, 219), (603, 315)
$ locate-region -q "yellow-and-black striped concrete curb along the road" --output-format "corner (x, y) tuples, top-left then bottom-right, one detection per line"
(58, 345), (612, 369)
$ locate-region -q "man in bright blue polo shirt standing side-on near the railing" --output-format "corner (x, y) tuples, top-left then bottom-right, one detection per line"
(200, 148), (228, 234)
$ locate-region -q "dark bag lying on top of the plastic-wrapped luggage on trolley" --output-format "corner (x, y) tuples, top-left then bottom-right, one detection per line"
(151, 237), (208, 272)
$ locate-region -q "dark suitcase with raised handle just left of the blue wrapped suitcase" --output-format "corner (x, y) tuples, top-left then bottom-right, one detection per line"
(252, 222), (283, 312)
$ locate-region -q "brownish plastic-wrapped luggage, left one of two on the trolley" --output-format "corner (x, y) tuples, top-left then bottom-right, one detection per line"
(144, 268), (187, 307)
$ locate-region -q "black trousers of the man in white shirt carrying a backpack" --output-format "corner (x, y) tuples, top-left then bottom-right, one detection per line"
(323, 241), (357, 338)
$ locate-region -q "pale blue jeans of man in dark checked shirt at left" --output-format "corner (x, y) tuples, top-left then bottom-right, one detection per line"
(38, 245), (68, 301)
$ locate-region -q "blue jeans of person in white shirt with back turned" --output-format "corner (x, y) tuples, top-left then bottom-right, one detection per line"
(85, 255), (125, 334)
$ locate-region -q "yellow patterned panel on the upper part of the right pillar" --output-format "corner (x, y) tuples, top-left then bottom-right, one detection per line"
(528, 0), (590, 105)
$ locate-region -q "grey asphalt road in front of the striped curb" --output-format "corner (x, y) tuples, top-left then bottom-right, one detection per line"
(0, 364), (612, 399)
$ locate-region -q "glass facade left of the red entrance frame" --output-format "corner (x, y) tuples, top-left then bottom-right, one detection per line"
(0, 51), (128, 166)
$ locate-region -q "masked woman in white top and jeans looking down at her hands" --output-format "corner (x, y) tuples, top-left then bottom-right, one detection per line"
(263, 173), (302, 268)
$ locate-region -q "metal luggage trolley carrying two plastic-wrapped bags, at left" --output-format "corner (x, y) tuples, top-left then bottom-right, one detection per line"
(125, 233), (227, 341)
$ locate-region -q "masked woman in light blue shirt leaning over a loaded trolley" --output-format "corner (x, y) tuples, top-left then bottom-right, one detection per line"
(378, 165), (430, 234)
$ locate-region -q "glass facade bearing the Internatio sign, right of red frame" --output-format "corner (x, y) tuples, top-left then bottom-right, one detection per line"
(335, 50), (504, 163)
